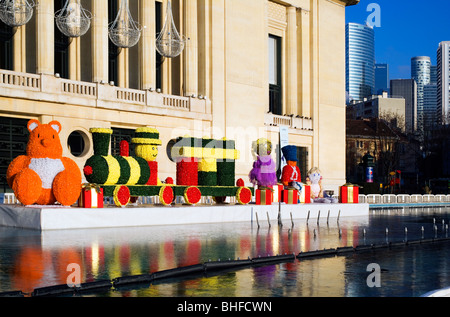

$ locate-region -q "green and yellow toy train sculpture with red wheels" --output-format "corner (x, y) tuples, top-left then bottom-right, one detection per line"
(83, 127), (254, 207)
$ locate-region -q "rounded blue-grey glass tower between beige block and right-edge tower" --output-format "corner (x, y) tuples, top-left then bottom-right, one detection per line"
(411, 56), (431, 131)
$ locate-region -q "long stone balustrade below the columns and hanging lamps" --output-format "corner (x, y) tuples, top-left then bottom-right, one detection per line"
(0, 70), (211, 120)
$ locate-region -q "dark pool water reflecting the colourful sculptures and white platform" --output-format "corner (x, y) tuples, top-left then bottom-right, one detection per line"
(0, 208), (450, 297)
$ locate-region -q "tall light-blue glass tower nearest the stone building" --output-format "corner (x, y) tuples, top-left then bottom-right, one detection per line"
(345, 23), (375, 101)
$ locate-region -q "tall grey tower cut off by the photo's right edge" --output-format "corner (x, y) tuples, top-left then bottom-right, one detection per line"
(436, 41), (450, 124)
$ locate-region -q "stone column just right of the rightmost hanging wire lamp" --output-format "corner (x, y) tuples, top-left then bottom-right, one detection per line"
(183, 0), (198, 96)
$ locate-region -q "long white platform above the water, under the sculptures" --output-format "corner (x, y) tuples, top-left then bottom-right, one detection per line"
(0, 204), (369, 230)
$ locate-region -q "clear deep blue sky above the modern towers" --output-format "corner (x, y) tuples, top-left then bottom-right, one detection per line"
(346, 0), (450, 79)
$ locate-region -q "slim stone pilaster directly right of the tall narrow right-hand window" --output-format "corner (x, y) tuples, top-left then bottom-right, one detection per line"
(286, 6), (298, 115)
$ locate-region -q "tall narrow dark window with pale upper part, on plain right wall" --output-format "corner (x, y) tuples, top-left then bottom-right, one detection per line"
(269, 35), (282, 115)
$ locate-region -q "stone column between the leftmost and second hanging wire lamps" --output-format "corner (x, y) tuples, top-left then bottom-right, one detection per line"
(36, 0), (55, 75)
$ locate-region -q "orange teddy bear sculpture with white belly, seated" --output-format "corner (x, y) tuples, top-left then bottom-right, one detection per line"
(6, 120), (81, 206)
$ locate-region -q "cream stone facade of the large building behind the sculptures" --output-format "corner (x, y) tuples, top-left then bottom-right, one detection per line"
(0, 0), (359, 190)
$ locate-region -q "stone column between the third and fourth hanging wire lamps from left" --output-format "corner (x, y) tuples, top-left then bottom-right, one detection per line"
(139, 0), (156, 89)
